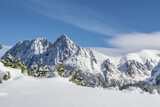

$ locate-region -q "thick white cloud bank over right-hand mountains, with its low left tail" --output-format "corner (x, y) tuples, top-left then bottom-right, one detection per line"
(90, 32), (160, 56)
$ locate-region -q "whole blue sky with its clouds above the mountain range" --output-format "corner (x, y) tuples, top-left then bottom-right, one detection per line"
(0, 0), (160, 55)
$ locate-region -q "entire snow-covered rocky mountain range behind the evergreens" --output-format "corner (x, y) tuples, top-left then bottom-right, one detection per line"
(2, 35), (160, 88)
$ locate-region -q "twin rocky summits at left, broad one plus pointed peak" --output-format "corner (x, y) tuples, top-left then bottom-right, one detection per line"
(2, 35), (78, 66)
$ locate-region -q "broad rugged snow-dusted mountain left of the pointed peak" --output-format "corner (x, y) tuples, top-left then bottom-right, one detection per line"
(2, 38), (51, 65)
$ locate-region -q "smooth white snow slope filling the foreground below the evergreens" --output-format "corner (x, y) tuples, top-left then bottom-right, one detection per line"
(0, 64), (160, 107)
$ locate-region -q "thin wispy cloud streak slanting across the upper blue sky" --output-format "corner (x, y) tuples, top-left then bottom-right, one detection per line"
(10, 0), (128, 36)
